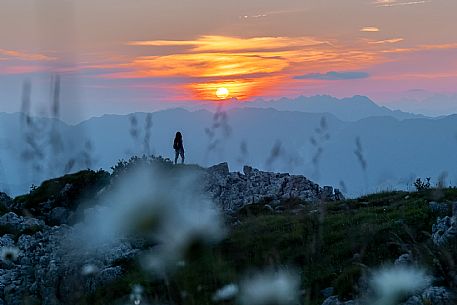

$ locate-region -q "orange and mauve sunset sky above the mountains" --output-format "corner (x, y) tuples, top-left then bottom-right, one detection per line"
(0, 0), (457, 117)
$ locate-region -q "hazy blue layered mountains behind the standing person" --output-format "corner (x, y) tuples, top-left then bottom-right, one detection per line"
(0, 96), (457, 196)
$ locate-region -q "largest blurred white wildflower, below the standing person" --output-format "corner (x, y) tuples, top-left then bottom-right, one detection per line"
(77, 165), (225, 271)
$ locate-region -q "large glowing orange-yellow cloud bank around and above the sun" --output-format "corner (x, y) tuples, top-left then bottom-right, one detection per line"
(117, 35), (378, 100)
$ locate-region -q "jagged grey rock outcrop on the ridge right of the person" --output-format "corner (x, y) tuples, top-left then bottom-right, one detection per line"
(205, 163), (344, 211)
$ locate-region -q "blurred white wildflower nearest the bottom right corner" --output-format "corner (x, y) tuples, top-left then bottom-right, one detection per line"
(370, 266), (431, 305)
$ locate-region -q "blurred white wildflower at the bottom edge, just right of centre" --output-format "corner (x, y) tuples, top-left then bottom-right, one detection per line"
(240, 271), (300, 305)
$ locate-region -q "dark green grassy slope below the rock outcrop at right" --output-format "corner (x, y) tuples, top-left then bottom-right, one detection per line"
(86, 189), (457, 305)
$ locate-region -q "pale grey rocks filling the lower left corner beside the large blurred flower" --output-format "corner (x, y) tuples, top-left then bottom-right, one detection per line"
(0, 213), (139, 305)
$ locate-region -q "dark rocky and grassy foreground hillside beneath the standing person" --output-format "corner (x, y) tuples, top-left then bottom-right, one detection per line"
(0, 159), (457, 305)
